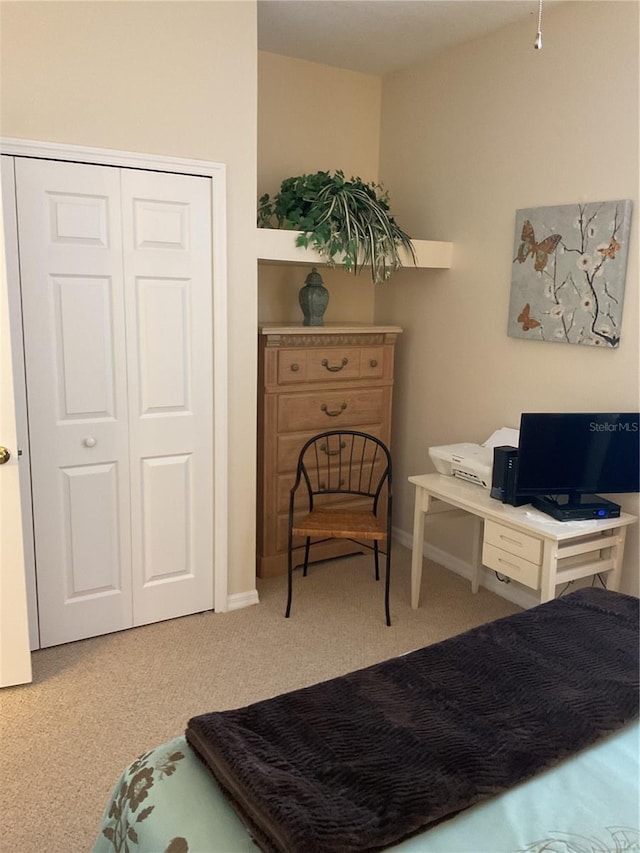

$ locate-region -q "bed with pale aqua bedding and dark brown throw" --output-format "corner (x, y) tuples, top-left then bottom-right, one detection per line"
(94, 589), (640, 853)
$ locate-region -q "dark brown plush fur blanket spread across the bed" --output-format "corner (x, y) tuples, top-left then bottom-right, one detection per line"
(186, 589), (638, 853)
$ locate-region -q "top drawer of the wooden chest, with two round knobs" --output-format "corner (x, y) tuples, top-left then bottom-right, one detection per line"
(278, 347), (384, 385)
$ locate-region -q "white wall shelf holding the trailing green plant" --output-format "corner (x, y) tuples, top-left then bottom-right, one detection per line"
(256, 228), (453, 269)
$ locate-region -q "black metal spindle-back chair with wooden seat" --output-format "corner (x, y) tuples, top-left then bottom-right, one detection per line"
(285, 430), (391, 625)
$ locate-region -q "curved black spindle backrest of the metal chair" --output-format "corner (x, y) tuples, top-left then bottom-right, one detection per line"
(294, 430), (391, 512)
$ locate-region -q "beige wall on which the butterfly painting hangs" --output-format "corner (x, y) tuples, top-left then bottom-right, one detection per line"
(375, 0), (640, 594)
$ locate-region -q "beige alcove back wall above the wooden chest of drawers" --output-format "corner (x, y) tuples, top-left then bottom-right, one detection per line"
(258, 52), (382, 323)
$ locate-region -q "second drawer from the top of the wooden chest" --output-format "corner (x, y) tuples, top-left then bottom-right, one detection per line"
(277, 388), (389, 433)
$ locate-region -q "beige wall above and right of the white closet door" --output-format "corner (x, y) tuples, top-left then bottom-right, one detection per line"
(0, 2), (257, 594)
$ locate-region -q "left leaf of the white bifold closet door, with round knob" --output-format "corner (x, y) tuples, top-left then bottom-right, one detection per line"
(16, 159), (132, 646)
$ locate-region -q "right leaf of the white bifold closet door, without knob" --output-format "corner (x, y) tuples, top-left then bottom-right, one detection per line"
(122, 170), (213, 624)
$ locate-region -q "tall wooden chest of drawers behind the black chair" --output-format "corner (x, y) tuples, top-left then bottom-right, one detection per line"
(257, 326), (402, 577)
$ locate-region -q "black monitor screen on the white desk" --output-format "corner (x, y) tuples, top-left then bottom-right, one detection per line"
(517, 412), (640, 496)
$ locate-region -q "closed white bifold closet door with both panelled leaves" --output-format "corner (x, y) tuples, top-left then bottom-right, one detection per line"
(16, 158), (213, 646)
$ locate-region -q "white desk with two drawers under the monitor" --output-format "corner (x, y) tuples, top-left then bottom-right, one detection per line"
(409, 474), (638, 608)
